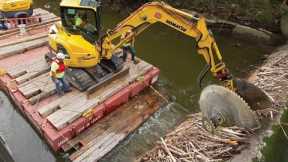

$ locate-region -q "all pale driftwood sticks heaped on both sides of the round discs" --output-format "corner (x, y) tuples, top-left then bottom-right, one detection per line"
(139, 45), (288, 162)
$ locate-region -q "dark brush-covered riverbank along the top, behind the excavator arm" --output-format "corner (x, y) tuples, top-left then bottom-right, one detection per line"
(104, 0), (283, 34)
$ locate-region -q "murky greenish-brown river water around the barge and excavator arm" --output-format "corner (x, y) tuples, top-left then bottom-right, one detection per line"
(0, 0), (268, 162)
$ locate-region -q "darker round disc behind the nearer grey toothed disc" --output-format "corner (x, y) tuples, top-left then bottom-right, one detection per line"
(235, 79), (274, 111)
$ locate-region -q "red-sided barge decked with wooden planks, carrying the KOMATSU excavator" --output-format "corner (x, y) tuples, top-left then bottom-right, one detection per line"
(0, 9), (161, 161)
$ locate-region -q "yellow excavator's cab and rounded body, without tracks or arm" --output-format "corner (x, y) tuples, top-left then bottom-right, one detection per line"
(49, 0), (101, 68)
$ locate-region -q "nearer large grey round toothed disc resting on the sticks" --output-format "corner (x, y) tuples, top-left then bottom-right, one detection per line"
(199, 85), (260, 132)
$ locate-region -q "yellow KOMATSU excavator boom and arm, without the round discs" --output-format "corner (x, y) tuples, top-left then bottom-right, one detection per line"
(101, 2), (234, 90)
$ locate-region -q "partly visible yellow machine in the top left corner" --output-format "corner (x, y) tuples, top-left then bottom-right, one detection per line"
(0, 0), (33, 18)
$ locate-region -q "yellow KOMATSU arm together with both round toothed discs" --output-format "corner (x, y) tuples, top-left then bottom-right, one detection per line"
(101, 2), (273, 132)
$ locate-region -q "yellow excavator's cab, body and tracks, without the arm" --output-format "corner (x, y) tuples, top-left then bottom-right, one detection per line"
(45, 0), (123, 91)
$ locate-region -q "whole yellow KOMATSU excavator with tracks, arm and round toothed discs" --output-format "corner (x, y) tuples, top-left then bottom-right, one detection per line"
(45, 0), (271, 130)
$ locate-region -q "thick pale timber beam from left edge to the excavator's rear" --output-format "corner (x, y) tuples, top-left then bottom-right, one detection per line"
(0, 37), (48, 59)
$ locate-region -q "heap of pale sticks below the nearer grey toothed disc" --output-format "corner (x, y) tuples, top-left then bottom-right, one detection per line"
(140, 113), (252, 162)
